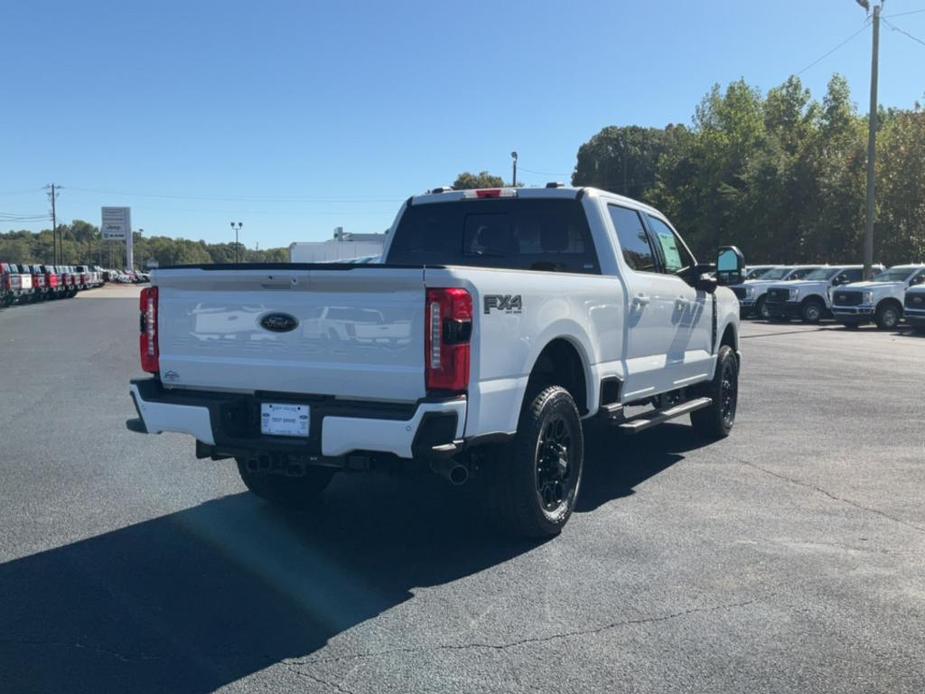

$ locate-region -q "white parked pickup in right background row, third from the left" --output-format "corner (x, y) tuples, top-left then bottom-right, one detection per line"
(832, 264), (925, 330)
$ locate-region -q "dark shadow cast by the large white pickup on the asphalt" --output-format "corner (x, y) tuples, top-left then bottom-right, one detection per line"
(0, 425), (708, 693)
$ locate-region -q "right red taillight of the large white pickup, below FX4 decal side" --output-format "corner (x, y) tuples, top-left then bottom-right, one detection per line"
(424, 289), (472, 393)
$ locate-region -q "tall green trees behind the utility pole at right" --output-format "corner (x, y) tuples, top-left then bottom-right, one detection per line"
(572, 75), (925, 265)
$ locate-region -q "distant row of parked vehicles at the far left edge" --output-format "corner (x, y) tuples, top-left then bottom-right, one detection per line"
(0, 263), (149, 306)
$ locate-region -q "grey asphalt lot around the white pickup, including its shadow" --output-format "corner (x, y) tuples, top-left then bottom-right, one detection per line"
(0, 288), (925, 694)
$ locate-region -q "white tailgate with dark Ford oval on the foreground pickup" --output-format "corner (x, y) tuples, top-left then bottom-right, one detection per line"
(152, 265), (425, 401)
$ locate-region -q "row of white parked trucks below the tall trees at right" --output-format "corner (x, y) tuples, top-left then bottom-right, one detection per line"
(732, 263), (925, 330)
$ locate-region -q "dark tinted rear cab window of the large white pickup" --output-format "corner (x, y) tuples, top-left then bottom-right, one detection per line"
(387, 198), (600, 274)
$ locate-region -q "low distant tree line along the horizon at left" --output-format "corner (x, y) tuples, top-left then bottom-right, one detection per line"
(0, 219), (289, 268)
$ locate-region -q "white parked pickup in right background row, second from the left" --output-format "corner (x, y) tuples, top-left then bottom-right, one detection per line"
(765, 265), (883, 323)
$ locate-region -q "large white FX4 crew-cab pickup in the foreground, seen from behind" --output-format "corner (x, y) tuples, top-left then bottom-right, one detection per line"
(127, 185), (744, 537)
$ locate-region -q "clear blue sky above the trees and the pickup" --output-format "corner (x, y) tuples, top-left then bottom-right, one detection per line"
(0, 0), (925, 248)
